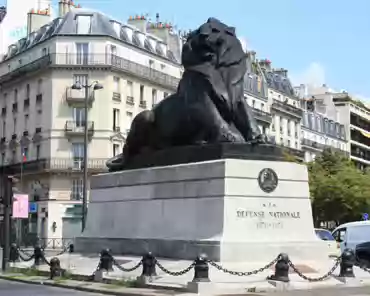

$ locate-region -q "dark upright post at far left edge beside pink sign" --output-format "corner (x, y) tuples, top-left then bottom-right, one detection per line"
(2, 174), (14, 271)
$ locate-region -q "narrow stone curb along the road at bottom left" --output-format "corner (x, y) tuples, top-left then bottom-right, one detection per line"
(0, 275), (165, 296)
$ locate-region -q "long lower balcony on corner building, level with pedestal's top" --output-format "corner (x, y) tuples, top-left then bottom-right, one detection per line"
(2, 157), (108, 175)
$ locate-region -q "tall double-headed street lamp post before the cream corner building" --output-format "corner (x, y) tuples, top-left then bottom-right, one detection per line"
(72, 81), (103, 232)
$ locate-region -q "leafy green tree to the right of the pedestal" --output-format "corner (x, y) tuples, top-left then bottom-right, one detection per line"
(308, 150), (370, 226)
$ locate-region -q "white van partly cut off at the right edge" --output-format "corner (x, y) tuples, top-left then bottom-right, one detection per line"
(332, 221), (370, 252)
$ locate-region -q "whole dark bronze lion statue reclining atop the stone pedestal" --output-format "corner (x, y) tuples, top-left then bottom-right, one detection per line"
(107, 18), (265, 171)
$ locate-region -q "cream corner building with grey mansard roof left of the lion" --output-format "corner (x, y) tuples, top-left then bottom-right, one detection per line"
(0, 3), (182, 243)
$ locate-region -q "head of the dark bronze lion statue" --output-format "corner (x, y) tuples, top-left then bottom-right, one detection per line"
(182, 18), (246, 69)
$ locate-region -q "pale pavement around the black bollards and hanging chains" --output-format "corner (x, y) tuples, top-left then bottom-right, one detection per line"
(8, 254), (370, 294)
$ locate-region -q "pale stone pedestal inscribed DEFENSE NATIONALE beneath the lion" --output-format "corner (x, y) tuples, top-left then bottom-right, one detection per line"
(76, 159), (328, 263)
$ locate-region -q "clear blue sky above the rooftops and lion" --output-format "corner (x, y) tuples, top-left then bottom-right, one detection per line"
(13, 0), (370, 98)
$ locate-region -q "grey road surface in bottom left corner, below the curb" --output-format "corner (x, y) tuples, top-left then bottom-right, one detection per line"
(0, 280), (102, 296)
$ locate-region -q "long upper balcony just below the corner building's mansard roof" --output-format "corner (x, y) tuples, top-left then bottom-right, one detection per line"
(0, 53), (179, 91)
